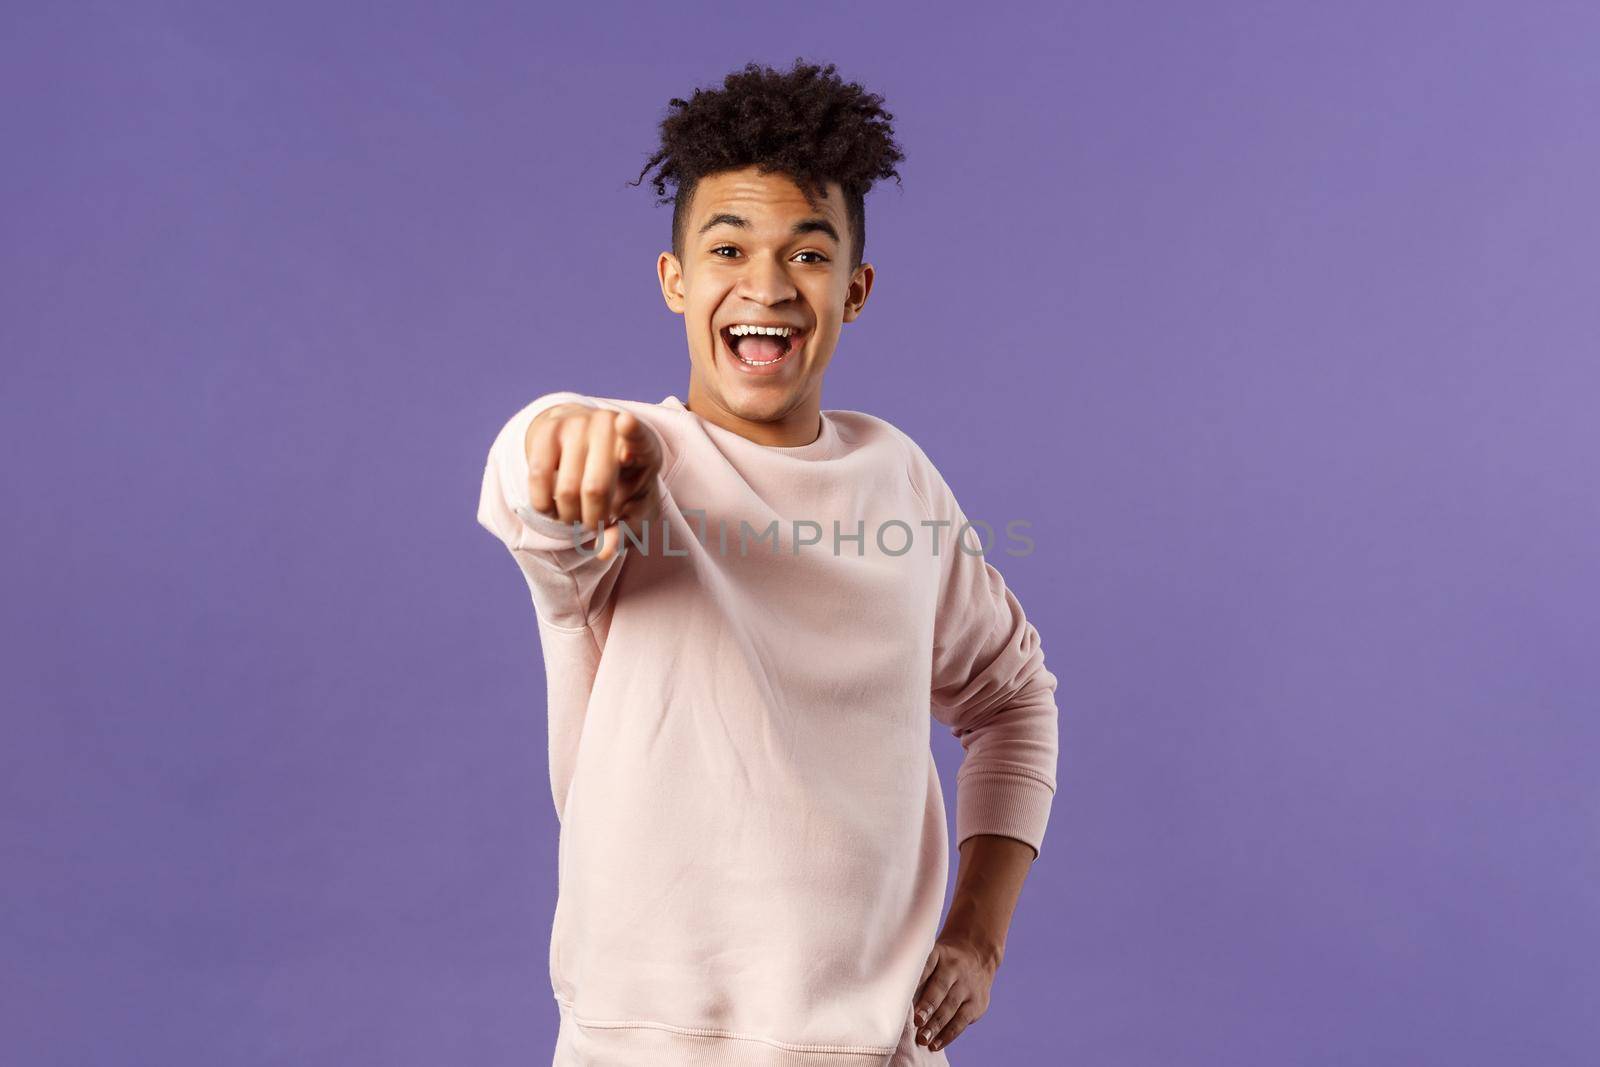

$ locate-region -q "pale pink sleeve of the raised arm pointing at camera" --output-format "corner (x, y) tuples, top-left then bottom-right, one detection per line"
(478, 392), (666, 630)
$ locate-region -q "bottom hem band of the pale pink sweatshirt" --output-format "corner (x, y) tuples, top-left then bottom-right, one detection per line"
(555, 997), (894, 1067)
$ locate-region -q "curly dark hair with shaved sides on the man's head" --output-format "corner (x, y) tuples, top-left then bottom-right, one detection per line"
(627, 58), (906, 270)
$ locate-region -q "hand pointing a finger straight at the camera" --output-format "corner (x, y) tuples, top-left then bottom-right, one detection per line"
(523, 403), (662, 560)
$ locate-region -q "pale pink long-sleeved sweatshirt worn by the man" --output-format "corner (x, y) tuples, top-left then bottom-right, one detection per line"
(478, 392), (1058, 1067)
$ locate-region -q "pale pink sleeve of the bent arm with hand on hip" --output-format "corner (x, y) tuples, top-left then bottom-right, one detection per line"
(907, 438), (1059, 859)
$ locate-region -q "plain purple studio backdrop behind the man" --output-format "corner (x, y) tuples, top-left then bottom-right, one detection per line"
(0, 3), (1600, 1067)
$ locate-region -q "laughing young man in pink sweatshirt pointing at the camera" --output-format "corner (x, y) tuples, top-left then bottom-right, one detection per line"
(478, 61), (1058, 1067)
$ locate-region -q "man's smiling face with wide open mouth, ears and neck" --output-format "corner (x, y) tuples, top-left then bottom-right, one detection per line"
(656, 166), (872, 446)
